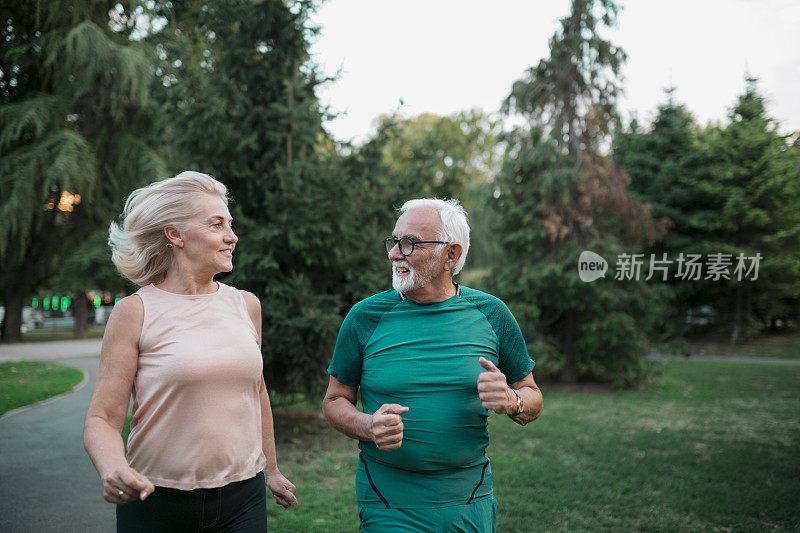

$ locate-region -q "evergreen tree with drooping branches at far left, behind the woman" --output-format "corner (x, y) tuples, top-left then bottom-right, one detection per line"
(0, 0), (162, 340)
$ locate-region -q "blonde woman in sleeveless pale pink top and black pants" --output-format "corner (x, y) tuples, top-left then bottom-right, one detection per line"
(83, 172), (297, 532)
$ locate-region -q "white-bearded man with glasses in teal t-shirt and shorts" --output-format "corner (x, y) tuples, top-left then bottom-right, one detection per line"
(323, 199), (542, 533)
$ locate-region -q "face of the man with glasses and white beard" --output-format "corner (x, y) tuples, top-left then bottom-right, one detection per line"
(389, 208), (445, 293)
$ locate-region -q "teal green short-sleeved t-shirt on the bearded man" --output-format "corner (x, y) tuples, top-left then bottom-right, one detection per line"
(328, 287), (534, 502)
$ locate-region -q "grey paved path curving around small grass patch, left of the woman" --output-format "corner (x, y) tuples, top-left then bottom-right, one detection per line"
(0, 341), (115, 533)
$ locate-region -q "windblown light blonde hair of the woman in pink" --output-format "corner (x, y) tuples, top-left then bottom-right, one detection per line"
(108, 171), (228, 286)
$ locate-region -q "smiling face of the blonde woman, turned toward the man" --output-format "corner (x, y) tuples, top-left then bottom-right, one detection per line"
(177, 194), (234, 275)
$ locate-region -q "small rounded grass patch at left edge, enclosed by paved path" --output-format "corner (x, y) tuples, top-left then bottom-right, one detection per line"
(0, 361), (83, 415)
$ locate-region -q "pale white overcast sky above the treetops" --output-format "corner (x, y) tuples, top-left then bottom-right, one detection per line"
(311, 0), (800, 142)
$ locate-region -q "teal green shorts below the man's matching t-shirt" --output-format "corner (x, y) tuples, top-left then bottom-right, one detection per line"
(358, 495), (497, 533)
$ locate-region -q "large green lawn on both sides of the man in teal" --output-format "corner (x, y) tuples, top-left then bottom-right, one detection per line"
(269, 361), (800, 533)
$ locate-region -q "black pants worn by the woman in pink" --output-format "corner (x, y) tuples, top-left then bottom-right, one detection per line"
(117, 472), (267, 533)
